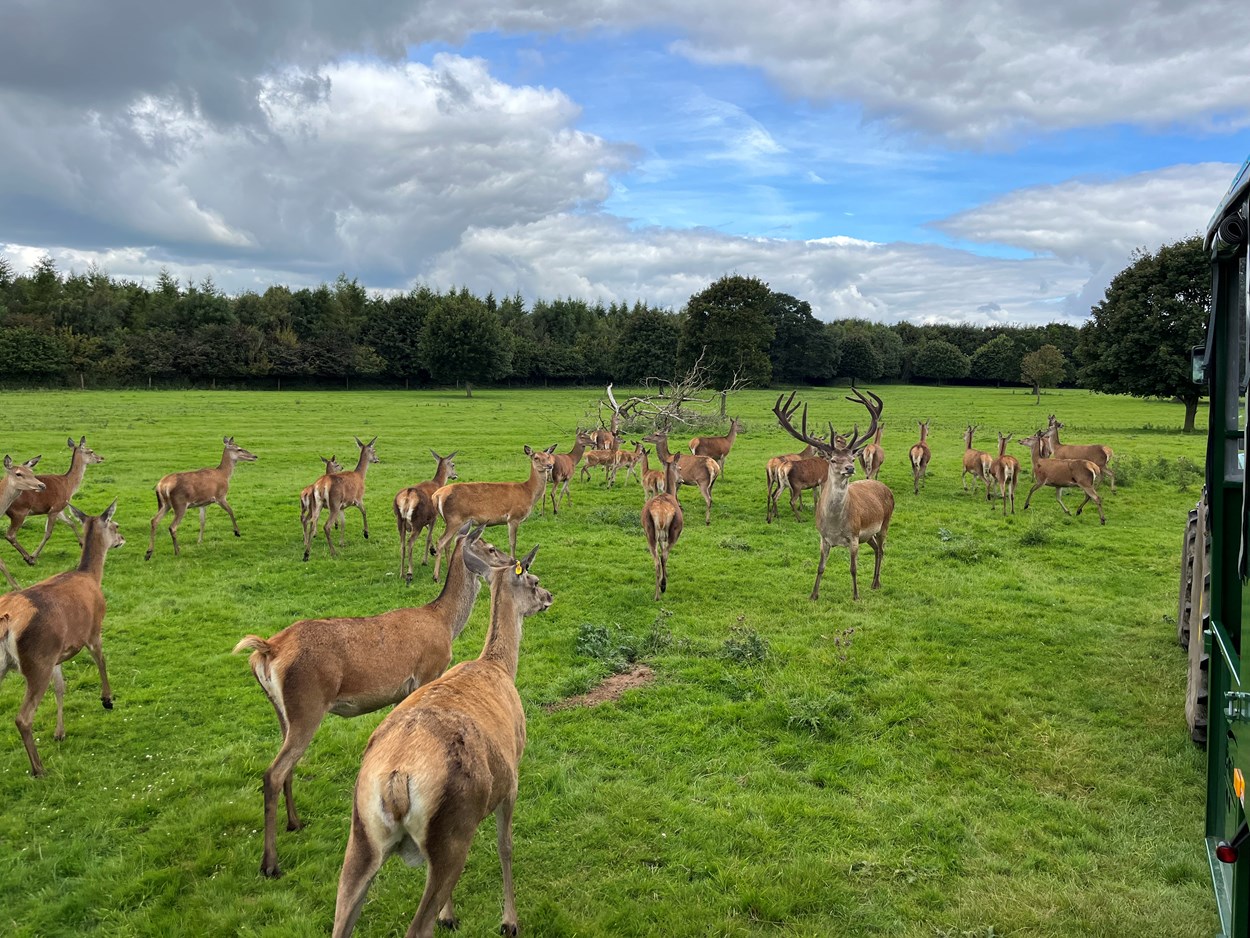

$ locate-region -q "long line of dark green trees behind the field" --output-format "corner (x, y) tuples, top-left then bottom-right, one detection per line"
(0, 239), (1209, 423)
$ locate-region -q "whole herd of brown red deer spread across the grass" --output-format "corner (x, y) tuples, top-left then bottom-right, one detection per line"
(0, 388), (1115, 935)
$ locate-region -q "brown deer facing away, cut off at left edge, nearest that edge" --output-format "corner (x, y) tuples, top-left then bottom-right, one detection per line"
(0, 502), (126, 778)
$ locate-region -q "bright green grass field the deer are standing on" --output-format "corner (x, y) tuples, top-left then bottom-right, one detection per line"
(0, 388), (1216, 938)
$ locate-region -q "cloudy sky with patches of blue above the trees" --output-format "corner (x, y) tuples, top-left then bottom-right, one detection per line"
(0, 0), (1250, 324)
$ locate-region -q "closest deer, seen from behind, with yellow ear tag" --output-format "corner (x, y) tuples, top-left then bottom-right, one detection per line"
(334, 535), (551, 938)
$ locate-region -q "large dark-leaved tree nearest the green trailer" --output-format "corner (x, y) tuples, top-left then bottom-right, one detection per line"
(1076, 235), (1211, 431)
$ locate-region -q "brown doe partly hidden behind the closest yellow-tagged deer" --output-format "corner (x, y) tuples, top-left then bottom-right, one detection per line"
(234, 525), (509, 877)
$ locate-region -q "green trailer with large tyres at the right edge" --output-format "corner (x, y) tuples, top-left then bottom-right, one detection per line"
(1195, 160), (1250, 938)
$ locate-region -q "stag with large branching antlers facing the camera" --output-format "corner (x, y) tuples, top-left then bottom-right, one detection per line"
(773, 388), (894, 600)
